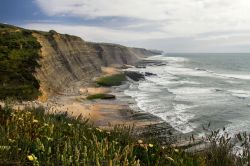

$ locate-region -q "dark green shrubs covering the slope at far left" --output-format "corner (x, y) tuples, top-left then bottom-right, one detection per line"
(0, 24), (41, 100)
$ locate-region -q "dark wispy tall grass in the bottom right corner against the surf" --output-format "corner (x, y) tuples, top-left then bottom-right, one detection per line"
(197, 124), (250, 166)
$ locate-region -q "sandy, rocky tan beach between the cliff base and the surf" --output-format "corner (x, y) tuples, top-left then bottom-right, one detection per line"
(0, 61), (182, 145)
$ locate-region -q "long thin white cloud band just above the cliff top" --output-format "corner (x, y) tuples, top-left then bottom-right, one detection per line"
(23, 23), (164, 43)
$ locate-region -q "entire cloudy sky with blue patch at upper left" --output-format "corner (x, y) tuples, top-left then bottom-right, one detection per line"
(0, 0), (250, 52)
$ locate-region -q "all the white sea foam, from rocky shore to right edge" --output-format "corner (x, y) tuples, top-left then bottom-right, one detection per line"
(125, 56), (250, 133)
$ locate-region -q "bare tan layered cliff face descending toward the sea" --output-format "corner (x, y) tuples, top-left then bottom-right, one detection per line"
(33, 32), (154, 98)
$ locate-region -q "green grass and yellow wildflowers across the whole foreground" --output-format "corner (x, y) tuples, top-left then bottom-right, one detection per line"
(0, 105), (249, 166)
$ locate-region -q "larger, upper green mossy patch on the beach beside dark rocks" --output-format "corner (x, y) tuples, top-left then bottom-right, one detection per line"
(96, 73), (126, 86)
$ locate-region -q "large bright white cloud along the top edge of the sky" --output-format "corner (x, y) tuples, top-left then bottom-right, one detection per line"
(36, 0), (250, 36)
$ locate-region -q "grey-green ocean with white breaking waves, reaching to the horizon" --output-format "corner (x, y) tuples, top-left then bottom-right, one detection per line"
(125, 53), (250, 135)
